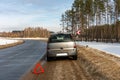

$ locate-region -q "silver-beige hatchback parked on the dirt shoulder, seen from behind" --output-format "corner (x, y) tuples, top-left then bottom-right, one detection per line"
(47, 33), (77, 61)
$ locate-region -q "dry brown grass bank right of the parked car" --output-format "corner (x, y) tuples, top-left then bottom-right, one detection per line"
(78, 46), (120, 80)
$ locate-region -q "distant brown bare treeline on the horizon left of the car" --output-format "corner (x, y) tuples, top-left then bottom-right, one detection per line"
(0, 27), (50, 37)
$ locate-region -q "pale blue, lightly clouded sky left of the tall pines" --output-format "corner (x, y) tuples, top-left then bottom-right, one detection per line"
(0, 0), (74, 32)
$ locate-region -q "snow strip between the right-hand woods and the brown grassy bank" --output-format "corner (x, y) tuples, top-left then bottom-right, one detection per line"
(77, 41), (120, 57)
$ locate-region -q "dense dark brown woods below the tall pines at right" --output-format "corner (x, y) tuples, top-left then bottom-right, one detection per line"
(79, 22), (120, 42)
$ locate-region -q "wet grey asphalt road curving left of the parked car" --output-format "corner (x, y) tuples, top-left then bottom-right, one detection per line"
(0, 40), (46, 80)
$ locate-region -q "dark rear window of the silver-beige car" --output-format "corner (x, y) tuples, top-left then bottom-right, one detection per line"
(49, 34), (72, 43)
